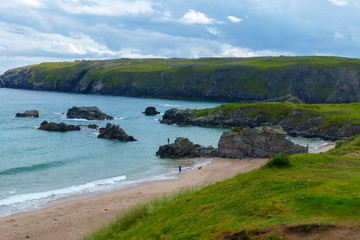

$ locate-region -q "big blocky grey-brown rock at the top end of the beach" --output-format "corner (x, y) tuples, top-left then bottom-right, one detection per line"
(218, 126), (306, 158)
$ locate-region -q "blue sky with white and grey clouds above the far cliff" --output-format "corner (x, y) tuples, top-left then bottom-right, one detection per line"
(0, 0), (360, 74)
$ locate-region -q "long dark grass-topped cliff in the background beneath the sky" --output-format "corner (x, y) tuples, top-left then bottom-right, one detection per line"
(0, 57), (360, 103)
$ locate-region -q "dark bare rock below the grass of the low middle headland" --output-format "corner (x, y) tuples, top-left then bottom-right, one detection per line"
(161, 106), (360, 141)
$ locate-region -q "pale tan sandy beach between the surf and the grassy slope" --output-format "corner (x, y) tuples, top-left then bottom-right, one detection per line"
(0, 144), (335, 240)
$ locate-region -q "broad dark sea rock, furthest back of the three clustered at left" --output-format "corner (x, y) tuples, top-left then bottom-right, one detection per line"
(66, 106), (114, 120)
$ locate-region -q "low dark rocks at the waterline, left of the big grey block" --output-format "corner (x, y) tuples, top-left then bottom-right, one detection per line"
(156, 137), (217, 159)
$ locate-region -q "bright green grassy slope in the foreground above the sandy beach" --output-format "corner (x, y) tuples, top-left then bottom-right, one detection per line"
(85, 136), (360, 240)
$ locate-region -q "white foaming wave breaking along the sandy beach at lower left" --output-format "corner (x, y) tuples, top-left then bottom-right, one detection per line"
(0, 176), (126, 217)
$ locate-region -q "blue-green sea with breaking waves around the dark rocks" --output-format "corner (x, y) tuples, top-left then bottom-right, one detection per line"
(0, 88), (327, 217)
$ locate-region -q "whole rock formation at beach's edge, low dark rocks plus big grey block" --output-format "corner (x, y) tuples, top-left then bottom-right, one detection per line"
(156, 126), (306, 159)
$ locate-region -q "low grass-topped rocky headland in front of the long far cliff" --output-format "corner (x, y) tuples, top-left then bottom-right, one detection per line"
(161, 102), (360, 140)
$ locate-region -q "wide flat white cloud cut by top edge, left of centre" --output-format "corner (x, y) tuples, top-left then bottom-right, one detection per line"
(57, 0), (153, 16)
